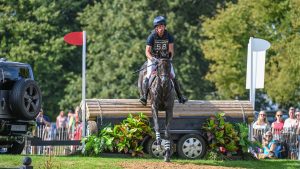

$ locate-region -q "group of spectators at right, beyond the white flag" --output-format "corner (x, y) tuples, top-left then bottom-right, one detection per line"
(253, 107), (300, 159)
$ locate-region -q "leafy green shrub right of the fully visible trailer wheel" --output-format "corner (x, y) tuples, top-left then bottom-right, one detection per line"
(203, 113), (261, 160)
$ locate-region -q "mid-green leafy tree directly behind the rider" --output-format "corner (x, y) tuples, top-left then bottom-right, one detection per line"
(65, 0), (224, 107)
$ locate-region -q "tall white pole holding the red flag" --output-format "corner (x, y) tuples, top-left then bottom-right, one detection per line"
(82, 31), (86, 151)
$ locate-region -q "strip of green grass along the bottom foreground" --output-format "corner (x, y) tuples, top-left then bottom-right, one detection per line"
(0, 155), (300, 169)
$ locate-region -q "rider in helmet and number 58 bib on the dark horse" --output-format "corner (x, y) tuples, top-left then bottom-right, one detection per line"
(140, 16), (187, 105)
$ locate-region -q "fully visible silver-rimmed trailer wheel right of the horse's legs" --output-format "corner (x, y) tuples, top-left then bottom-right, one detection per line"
(177, 134), (206, 159)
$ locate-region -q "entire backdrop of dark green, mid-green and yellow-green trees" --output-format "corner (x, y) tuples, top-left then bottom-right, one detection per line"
(0, 0), (300, 117)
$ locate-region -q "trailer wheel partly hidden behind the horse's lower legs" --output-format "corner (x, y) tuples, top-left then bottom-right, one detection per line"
(147, 139), (173, 158)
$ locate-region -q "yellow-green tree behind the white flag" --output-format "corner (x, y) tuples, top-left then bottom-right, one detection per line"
(201, 0), (300, 106)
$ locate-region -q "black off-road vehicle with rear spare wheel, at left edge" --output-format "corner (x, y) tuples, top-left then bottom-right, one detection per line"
(0, 58), (42, 154)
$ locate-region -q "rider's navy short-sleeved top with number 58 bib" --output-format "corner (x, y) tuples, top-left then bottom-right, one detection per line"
(147, 30), (174, 58)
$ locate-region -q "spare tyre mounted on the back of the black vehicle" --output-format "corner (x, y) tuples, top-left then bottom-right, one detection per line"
(10, 79), (42, 120)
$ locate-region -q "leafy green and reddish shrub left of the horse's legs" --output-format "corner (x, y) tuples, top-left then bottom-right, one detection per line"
(82, 113), (153, 156)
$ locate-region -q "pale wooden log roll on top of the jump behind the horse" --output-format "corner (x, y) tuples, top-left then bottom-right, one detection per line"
(82, 99), (253, 121)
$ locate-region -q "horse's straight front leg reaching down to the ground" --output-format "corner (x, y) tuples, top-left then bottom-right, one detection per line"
(164, 108), (173, 162)
